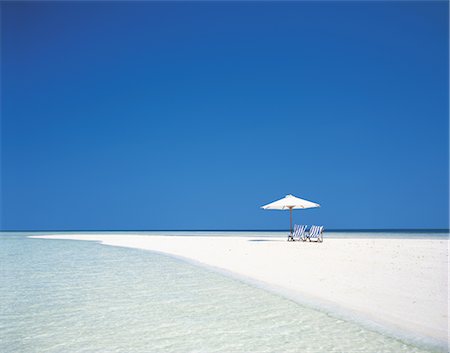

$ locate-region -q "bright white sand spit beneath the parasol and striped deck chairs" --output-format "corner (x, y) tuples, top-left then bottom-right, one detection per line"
(35, 234), (448, 344)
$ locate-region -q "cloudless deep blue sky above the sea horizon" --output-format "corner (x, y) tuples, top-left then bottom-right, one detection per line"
(1, 1), (449, 230)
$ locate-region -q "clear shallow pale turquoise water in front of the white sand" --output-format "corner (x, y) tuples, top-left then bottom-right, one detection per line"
(0, 234), (442, 353)
